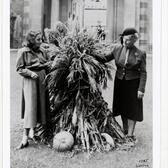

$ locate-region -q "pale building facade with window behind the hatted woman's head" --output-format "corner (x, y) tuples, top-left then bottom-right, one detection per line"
(107, 0), (152, 52)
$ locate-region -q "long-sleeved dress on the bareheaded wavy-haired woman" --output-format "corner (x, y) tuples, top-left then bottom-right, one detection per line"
(16, 47), (49, 128)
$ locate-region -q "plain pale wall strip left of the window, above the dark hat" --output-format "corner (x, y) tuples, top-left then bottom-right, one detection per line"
(106, 0), (136, 42)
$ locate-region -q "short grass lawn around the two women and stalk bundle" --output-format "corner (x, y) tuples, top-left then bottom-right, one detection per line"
(10, 51), (152, 168)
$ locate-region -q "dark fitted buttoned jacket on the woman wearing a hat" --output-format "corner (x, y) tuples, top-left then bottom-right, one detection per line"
(93, 45), (147, 93)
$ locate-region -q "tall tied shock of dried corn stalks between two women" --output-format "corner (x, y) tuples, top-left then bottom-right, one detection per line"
(37, 22), (124, 152)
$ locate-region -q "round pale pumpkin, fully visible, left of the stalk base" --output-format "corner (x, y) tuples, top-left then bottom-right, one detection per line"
(53, 131), (74, 152)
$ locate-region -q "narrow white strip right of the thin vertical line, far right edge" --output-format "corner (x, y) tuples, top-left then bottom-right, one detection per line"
(160, 0), (168, 168)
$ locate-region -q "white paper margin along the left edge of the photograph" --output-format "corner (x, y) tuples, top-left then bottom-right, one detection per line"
(1, 0), (10, 168)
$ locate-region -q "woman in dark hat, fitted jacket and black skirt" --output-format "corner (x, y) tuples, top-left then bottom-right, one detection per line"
(92, 28), (147, 146)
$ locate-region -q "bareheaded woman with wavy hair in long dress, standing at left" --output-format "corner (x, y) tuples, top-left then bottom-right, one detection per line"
(16, 31), (49, 149)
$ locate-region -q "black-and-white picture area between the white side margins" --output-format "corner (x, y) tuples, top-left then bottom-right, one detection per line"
(0, 0), (168, 168)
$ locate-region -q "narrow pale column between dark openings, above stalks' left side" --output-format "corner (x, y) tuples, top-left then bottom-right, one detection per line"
(51, 0), (60, 28)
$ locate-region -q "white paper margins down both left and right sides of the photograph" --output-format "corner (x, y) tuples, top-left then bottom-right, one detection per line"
(0, 0), (168, 168)
